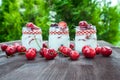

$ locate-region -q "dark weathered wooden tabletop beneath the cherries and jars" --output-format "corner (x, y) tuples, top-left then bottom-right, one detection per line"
(0, 41), (120, 80)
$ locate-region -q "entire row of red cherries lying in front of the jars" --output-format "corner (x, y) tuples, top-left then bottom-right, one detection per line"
(1, 43), (112, 60)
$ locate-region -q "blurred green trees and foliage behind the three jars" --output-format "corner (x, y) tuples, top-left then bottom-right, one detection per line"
(0, 0), (120, 46)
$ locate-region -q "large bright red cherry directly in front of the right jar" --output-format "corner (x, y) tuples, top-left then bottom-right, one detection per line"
(82, 47), (96, 58)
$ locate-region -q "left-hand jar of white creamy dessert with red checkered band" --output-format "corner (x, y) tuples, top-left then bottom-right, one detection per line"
(22, 22), (42, 51)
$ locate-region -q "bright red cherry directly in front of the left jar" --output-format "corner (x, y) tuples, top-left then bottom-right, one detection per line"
(25, 48), (36, 60)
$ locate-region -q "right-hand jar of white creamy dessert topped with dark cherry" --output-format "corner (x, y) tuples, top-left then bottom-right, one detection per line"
(75, 21), (97, 53)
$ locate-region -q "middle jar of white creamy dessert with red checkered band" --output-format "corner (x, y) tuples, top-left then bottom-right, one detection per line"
(48, 21), (70, 50)
